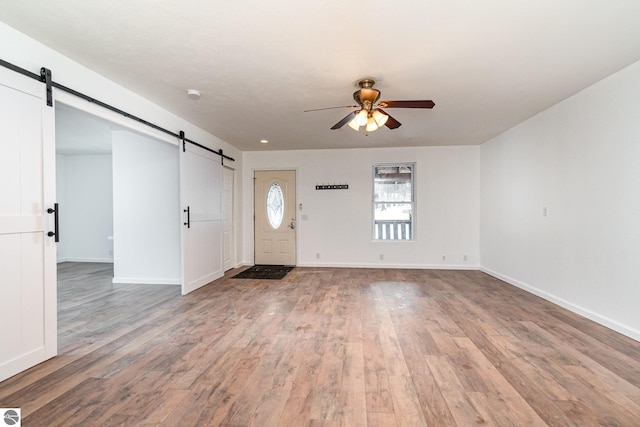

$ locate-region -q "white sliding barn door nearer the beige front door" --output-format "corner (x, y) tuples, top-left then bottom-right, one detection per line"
(180, 144), (224, 295)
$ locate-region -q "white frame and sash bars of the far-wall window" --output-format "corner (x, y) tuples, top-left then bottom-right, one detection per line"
(371, 162), (417, 242)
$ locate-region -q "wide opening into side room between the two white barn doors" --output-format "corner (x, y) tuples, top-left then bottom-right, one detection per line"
(55, 103), (181, 350)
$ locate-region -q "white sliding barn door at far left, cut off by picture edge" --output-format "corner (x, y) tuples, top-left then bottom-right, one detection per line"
(0, 68), (57, 381)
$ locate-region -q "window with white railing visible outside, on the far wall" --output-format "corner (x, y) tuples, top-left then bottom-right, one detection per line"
(373, 163), (415, 240)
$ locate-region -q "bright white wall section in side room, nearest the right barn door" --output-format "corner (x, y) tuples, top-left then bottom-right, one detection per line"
(113, 131), (182, 284)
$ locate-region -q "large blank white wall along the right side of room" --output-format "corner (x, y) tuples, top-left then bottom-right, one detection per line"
(480, 59), (640, 339)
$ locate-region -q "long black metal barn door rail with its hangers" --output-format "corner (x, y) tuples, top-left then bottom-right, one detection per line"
(0, 59), (235, 162)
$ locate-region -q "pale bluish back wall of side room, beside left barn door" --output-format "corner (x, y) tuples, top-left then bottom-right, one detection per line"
(56, 154), (113, 262)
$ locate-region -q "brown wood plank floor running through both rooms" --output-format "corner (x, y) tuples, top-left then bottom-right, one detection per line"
(0, 264), (640, 427)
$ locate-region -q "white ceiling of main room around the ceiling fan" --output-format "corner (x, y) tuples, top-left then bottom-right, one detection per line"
(0, 0), (640, 150)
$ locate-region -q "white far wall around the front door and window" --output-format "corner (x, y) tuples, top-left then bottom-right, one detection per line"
(242, 145), (479, 268)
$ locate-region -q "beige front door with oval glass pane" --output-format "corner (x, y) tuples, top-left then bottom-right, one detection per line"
(254, 170), (296, 265)
